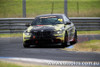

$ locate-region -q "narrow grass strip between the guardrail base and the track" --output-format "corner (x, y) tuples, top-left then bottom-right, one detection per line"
(0, 31), (100, 37)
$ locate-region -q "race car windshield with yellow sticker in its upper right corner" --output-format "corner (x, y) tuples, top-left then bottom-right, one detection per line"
(31, 16), (63, 25)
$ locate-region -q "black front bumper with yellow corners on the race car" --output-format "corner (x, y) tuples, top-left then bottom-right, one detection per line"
(23, 33), (64, 44)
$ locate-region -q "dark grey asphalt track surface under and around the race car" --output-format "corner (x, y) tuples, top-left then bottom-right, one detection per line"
(0, 35), (100, 62)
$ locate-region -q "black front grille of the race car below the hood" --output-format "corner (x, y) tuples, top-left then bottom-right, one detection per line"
(33, 31), (53, 39)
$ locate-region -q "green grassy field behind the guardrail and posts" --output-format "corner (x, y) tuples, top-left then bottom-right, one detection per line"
(0, 0), (100, 18)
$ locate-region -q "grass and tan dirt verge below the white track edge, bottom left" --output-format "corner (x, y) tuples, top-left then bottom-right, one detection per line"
(0, 60), (50, 67)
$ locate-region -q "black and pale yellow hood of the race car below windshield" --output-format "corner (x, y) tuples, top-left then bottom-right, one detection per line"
(27, 24), (64, 32)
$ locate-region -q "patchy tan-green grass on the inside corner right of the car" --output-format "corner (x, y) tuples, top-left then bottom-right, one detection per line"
(64, 40), (100, 52)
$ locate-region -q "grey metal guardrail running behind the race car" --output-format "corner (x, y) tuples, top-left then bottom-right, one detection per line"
(0, 17), (100, 33)
